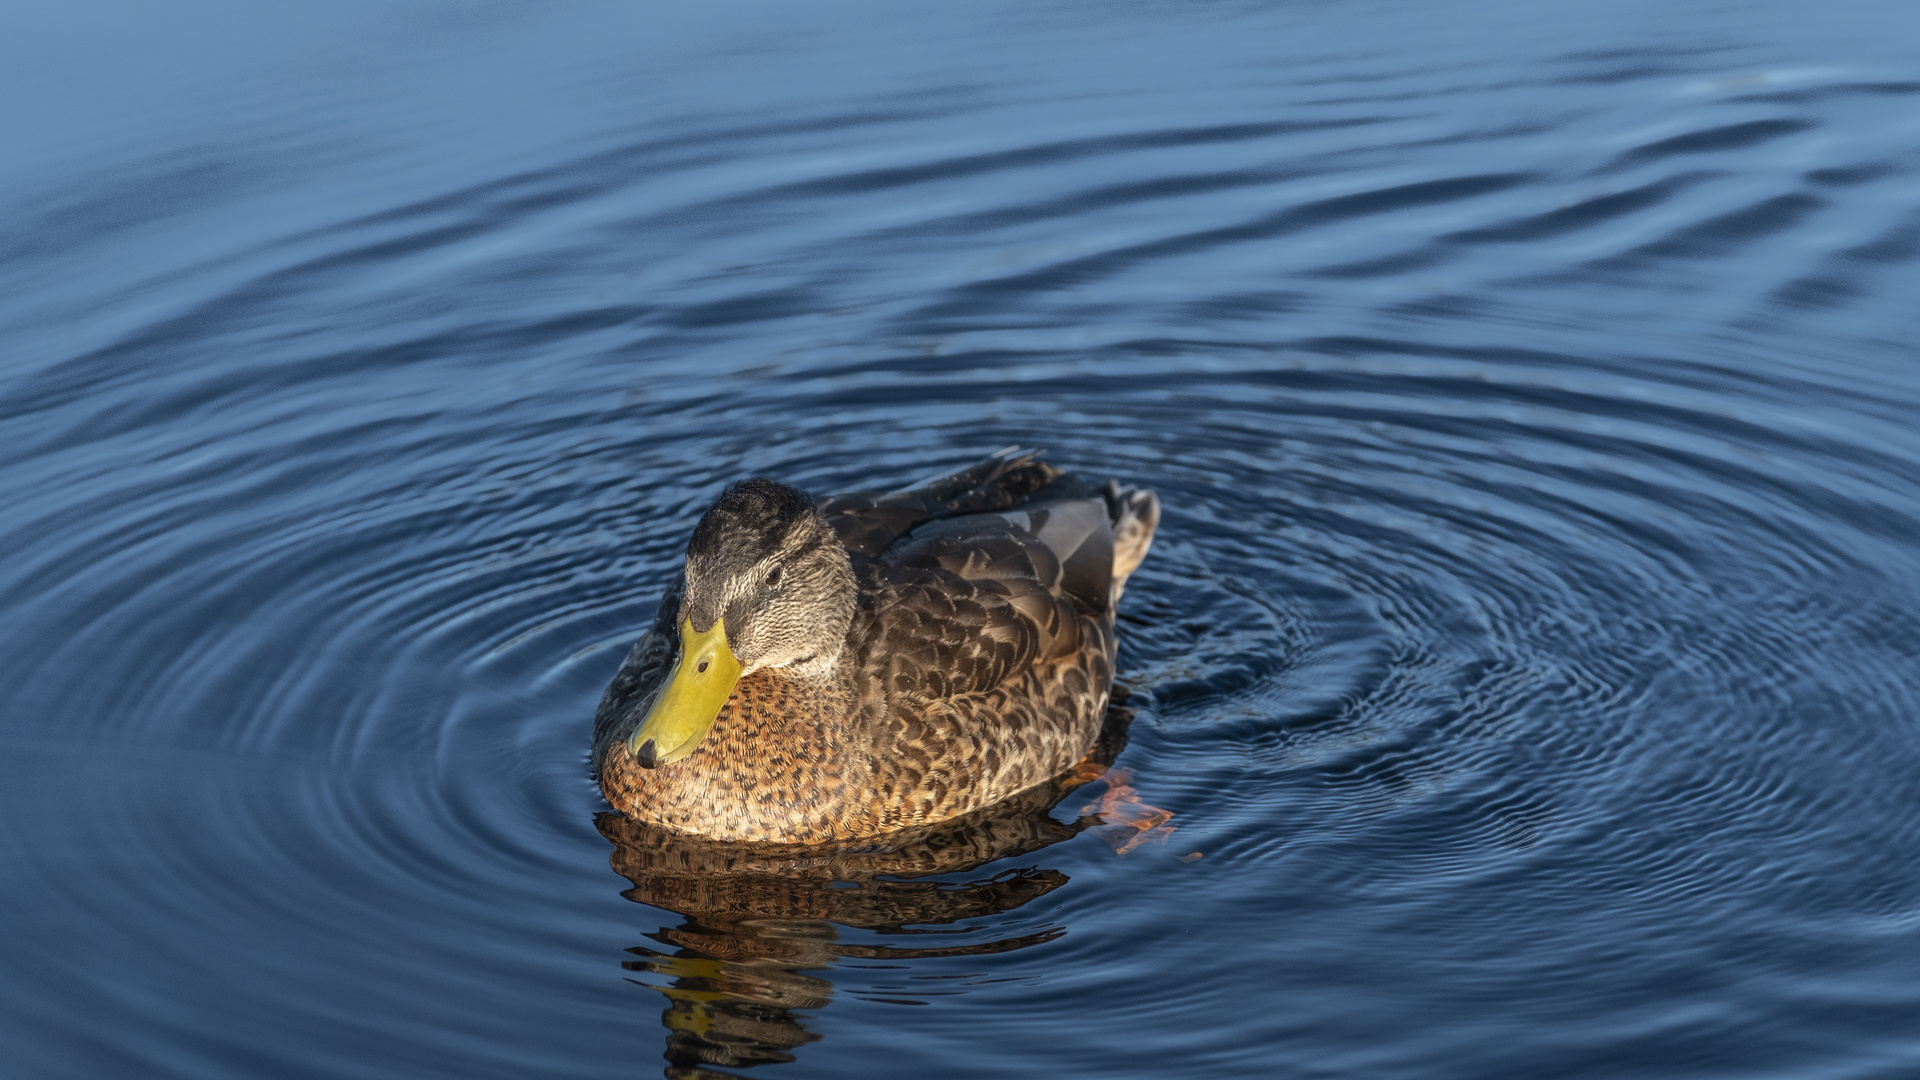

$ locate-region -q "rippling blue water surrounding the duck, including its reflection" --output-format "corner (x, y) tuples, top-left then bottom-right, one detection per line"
(0, 0), (1920, 1080)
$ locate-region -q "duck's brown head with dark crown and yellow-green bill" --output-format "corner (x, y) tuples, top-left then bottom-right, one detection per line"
(628, 479), (854, 769)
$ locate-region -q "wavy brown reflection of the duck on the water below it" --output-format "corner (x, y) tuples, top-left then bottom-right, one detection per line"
(597, 707), (1131, 1078)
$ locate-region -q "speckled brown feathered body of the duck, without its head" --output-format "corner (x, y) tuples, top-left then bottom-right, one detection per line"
(593, 445), (1158, 844)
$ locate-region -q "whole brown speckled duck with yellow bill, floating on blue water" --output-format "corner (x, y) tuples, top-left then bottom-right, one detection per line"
(593, 452), (1160, 844)
